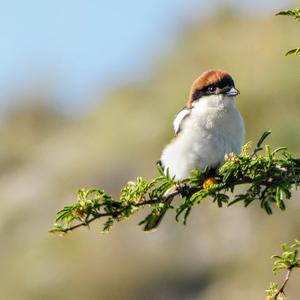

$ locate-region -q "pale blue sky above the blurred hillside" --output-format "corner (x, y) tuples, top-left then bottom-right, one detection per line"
(0, 0), (293, 115)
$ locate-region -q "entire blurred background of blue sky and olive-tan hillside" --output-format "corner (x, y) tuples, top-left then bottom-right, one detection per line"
(0, 0), (300, 300)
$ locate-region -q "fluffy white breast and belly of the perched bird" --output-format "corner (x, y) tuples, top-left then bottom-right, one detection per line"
(161, 96), (245, 179)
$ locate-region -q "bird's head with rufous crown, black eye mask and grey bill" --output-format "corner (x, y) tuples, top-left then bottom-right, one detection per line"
(187, 70), (240, 108)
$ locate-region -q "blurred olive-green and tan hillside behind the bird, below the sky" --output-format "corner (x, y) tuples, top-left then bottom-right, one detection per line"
(0, 9), (300, 300)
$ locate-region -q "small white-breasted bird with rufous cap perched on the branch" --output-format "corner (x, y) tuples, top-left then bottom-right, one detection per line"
(144, 69), (245, 231)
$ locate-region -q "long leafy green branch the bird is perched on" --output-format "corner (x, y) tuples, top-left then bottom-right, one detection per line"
(51, 131), (300, 233)
